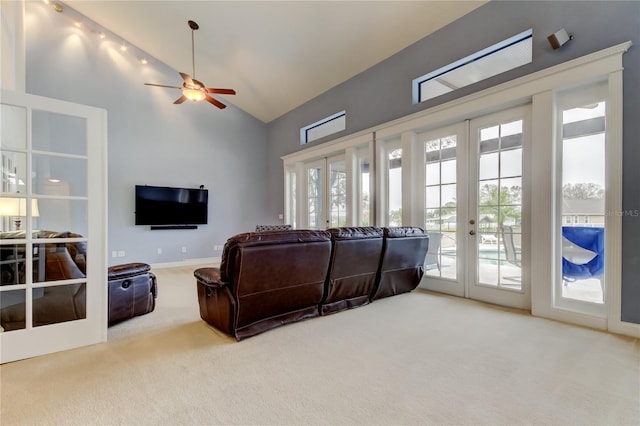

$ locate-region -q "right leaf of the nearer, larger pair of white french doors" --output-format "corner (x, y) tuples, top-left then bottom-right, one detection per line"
(465, 107), (531, 309)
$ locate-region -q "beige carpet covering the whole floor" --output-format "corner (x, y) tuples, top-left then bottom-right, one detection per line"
(0, 267), (640, 425)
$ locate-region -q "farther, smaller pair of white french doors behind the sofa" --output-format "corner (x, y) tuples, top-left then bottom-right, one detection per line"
(305, 155), (347, 229)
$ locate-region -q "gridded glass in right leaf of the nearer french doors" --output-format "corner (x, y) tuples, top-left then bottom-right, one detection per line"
(476, 120), (523, 290)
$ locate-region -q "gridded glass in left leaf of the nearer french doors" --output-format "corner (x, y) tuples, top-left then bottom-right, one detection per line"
(424, 135), (457, 280)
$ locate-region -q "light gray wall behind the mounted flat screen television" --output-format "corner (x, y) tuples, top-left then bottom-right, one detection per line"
(25, 2), (267, 265)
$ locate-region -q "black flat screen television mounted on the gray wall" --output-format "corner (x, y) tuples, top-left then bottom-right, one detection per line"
(135, 185), (209, 227)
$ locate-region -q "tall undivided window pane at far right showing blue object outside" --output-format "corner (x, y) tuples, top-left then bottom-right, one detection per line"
(562, 102), (605, 304)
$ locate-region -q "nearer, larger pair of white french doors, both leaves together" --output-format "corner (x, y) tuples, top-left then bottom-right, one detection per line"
(417, 107), (531, 309)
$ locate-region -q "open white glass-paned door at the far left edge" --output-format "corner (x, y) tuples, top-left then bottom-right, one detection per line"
(0, 92), (107, 363)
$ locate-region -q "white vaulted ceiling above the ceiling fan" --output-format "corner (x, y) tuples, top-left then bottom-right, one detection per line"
(64, 0), (485, 122)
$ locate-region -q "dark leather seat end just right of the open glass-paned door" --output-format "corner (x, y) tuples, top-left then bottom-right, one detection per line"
(108, 262), (158, 325)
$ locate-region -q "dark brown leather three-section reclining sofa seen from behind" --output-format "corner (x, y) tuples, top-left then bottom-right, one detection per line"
(194, 227), (429, 340)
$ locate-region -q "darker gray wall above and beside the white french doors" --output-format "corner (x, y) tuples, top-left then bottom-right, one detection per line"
(267, 1), (640, 323)
